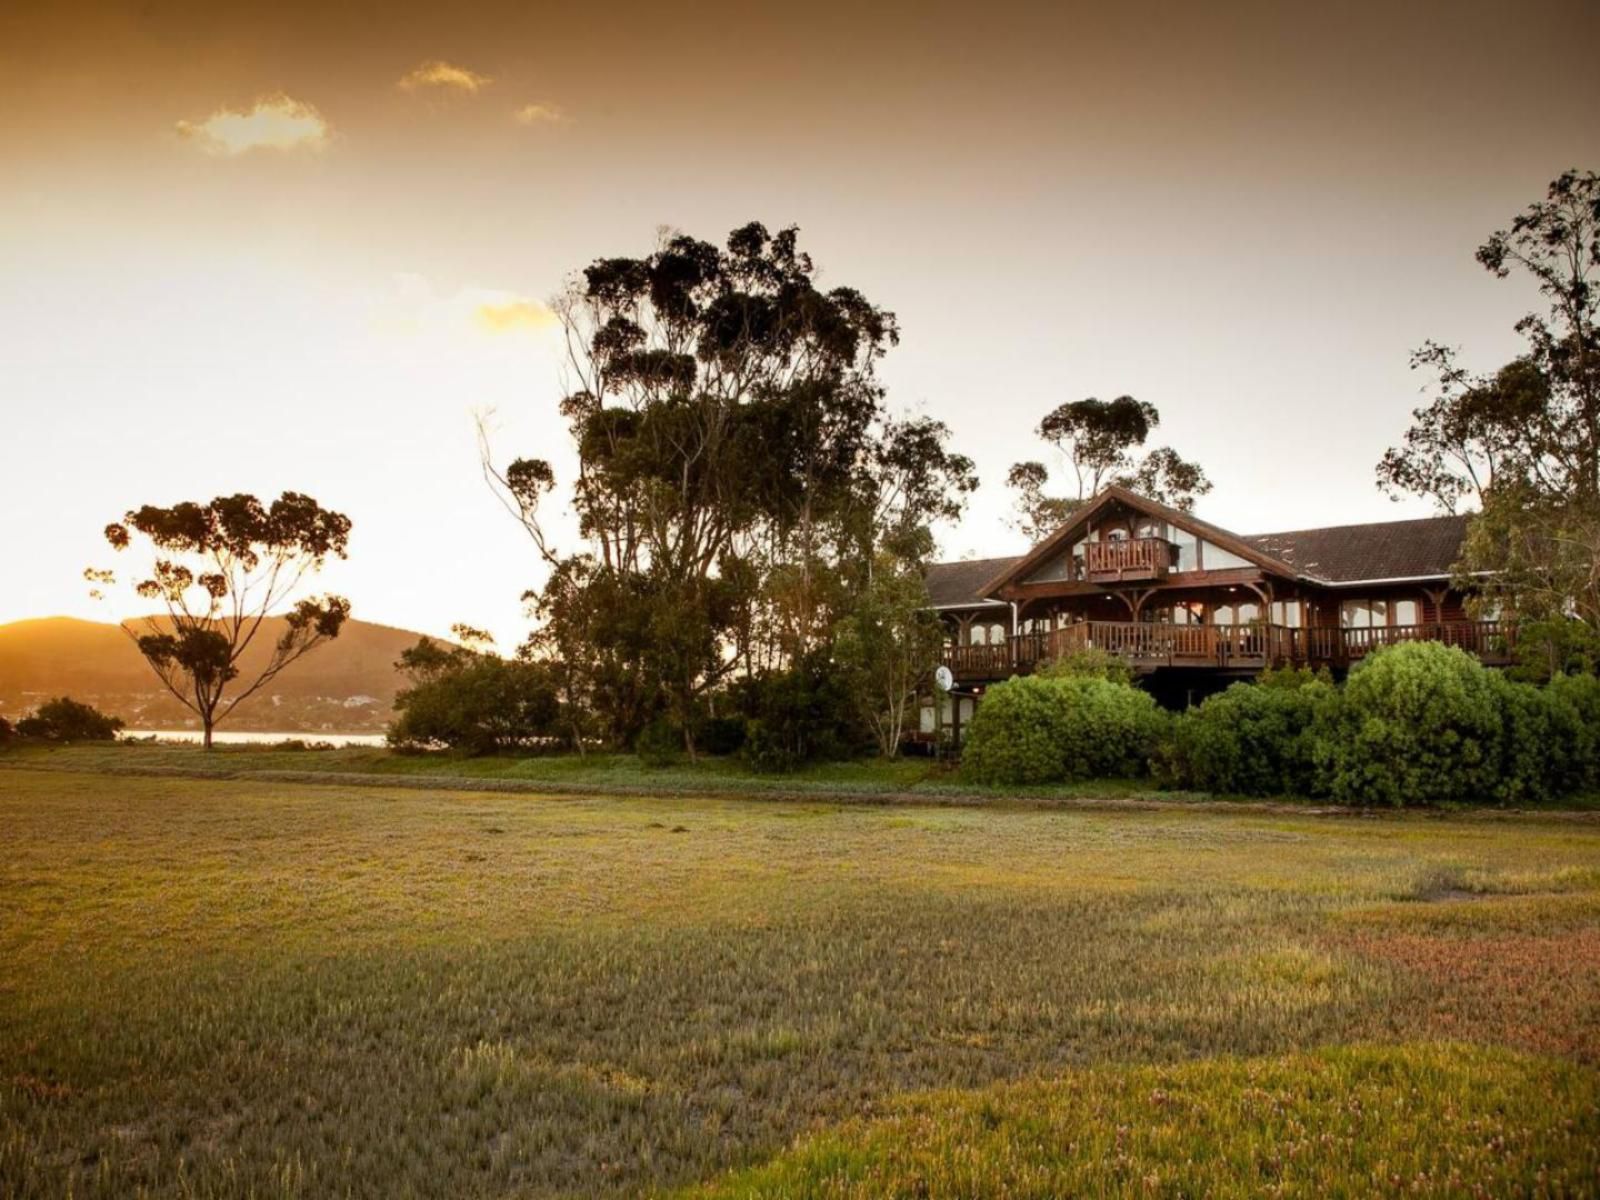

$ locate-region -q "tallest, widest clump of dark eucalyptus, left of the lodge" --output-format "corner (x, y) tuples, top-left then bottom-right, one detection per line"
(483, 224), (973, 755)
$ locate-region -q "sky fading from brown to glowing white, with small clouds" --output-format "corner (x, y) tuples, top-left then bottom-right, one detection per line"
(0, 0), (1600, 645)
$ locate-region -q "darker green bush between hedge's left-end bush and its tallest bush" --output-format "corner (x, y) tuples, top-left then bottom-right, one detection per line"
(1165, 672), (1338, 795)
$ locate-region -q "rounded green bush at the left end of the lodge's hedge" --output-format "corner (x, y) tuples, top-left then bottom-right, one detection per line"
(962, 675), (1166, 784)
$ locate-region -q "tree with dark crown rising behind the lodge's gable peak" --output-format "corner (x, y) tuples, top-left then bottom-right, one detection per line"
(1006, 395), (1211, 541)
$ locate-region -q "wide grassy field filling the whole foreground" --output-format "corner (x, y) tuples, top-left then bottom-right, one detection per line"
(0, 747), (1600, 1198)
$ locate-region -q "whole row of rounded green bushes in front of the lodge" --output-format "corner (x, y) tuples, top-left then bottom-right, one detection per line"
(963, 642), (1600, 805)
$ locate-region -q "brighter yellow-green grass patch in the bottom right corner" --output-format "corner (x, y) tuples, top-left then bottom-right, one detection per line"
(685, 1045), (1600, 1200)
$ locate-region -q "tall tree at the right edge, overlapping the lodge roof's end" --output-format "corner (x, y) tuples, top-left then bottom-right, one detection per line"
(1378, 171), (1600, 629)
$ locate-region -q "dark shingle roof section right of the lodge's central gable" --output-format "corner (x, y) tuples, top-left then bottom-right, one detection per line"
(1242, 517), (1467, 584)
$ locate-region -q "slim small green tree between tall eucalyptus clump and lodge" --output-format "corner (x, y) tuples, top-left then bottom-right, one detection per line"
(834, 555), (944, 758)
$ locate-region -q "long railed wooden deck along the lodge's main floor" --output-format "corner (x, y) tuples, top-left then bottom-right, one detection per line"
(944, 621), (1514, 683)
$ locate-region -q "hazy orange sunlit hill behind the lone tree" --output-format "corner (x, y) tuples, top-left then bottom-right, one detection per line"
(0, 616), (435, 733)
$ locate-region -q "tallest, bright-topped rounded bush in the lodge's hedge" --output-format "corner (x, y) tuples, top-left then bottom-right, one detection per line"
(1315, 642), (1504, 805)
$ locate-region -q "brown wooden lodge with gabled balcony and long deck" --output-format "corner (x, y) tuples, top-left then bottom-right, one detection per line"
(925, 486), (1510, 726)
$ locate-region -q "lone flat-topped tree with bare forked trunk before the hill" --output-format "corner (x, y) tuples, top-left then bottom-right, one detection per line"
(99, 491), (350, 749)
